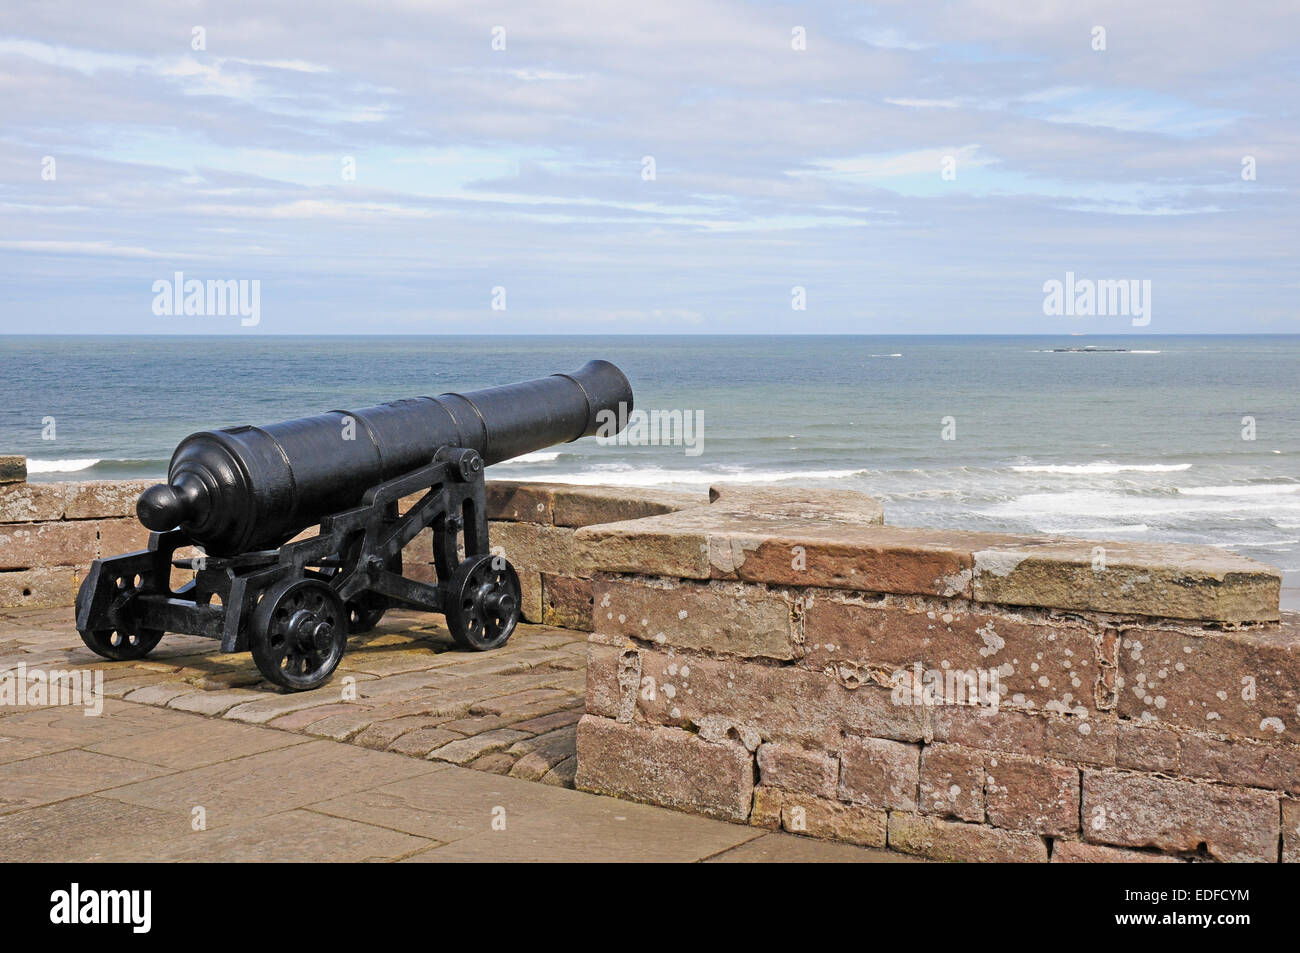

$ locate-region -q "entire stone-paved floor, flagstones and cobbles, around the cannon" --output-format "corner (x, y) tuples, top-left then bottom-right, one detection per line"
(0, 608), (905, 862)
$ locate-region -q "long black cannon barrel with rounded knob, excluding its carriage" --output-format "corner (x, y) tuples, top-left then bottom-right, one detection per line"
(137, 360), (632, 556)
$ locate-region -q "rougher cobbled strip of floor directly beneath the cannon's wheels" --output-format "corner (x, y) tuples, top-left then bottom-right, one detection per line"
(0, 608), (586, 788)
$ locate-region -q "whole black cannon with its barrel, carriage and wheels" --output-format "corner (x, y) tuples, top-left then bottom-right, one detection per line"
(77, 360), (632, 690)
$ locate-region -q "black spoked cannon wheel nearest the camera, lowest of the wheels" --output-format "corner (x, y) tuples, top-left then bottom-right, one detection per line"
(250, 579), (348, 692)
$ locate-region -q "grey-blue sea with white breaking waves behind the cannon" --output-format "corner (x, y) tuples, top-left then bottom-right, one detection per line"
(0, 334), (1300, 588)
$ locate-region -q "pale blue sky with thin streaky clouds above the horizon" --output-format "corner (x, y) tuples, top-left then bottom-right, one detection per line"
(0, 0), (1300, 335)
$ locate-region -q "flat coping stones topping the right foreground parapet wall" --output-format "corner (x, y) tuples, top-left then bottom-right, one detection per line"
(575, 488), (1282, 624)
